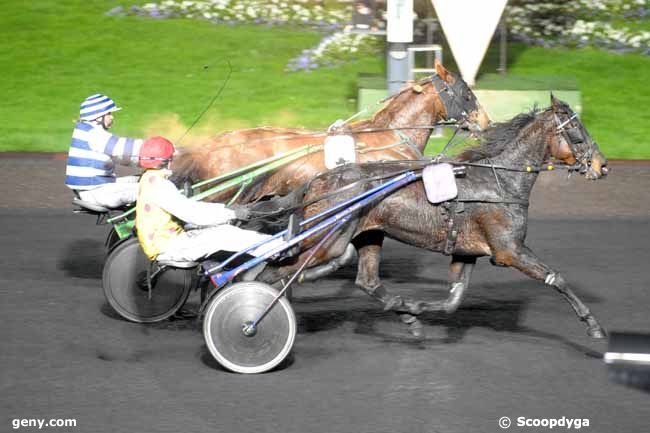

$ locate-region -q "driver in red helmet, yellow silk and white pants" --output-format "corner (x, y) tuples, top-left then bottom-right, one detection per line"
(135, 137), (283, 262)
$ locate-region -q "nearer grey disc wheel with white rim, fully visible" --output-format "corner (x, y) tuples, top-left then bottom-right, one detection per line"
(203, 281), (297, 373)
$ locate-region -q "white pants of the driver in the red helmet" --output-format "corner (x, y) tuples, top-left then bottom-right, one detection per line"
(157, 224), (284, 262)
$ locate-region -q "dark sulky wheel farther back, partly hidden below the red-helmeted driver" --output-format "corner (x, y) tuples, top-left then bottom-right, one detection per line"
(102, 238), (192, 323)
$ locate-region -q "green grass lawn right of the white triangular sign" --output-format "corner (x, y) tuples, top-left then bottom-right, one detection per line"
(486, 45), (650, 159)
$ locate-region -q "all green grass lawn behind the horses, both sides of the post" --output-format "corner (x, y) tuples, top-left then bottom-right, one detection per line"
(0, 0), (650, 158)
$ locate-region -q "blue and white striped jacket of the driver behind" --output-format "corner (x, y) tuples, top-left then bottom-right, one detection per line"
(65, 121), (143, 189)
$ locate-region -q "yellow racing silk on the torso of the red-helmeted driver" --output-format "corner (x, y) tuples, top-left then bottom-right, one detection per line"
(135, 169), (183, 260)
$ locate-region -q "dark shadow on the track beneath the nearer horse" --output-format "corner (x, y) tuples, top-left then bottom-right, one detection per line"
(294, 279), (603, 359)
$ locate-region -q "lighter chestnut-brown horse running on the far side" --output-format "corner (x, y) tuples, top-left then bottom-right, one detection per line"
(172, 63), (489, 203)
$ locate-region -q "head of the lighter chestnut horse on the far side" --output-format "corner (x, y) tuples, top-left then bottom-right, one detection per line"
(429, 60), (491, 131)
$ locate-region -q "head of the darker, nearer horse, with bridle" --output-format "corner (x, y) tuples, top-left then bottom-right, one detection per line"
(550, 94), (609, 180)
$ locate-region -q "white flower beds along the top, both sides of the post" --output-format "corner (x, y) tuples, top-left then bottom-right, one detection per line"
(114, 0), (650, 75)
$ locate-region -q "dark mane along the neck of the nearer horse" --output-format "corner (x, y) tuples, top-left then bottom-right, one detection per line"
(457, 107), (540, 162)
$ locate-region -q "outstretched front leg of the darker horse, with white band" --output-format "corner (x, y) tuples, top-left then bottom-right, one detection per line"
(504, 245), (606, 338)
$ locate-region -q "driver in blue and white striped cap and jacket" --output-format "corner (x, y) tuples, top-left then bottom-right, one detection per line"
(65, 94), (142, 208)
